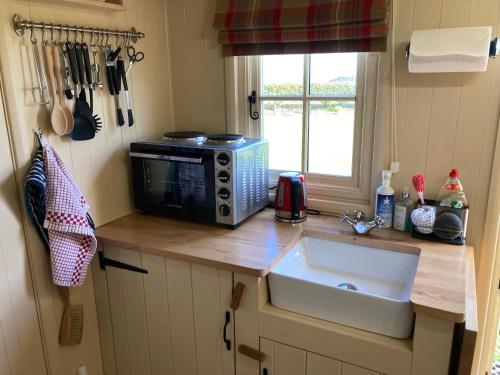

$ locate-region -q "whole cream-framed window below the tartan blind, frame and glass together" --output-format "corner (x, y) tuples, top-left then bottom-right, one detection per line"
(226, 53), (380, 212)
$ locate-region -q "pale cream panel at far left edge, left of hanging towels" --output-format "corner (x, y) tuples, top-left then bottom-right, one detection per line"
(0, 80), (47, 375)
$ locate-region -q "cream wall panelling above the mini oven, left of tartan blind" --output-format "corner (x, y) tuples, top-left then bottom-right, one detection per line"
(167, 0), (226, 133)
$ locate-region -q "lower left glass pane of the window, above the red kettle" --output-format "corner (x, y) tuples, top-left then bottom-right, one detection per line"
(262, 100), (303, 171)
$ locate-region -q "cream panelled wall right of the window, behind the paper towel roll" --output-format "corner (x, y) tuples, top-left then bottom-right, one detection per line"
(372, 0), (500, 265)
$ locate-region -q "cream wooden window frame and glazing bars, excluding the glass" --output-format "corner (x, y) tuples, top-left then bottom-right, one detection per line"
(225, 53), (380, 213)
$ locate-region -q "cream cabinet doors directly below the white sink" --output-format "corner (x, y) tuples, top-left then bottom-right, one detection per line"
(260, 338), (379, 375)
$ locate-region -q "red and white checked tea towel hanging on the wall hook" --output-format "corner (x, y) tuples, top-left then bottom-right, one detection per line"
(43, 145), (97, 286)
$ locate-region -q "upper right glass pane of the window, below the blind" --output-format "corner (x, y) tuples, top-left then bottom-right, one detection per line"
(309, 53), (357, 97)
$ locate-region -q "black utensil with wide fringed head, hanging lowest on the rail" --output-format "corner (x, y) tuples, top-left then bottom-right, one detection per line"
(67, 42), (97, 141)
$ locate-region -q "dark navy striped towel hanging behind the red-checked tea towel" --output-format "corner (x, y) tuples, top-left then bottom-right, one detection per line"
(24, 147), (49, 252)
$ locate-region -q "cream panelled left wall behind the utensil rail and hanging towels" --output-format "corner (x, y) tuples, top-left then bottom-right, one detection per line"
(0, 0), (173, 374)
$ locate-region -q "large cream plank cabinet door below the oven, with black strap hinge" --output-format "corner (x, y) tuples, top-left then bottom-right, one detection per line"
(94, 250), (234, 375)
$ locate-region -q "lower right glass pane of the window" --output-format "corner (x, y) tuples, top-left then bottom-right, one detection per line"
(309, 100), (354, 177)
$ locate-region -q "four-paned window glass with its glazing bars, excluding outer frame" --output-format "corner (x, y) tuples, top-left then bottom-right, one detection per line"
(260, 53), (358, 177)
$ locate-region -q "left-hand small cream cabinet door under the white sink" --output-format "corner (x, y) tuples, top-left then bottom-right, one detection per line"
(260, 338), (306, 375)
